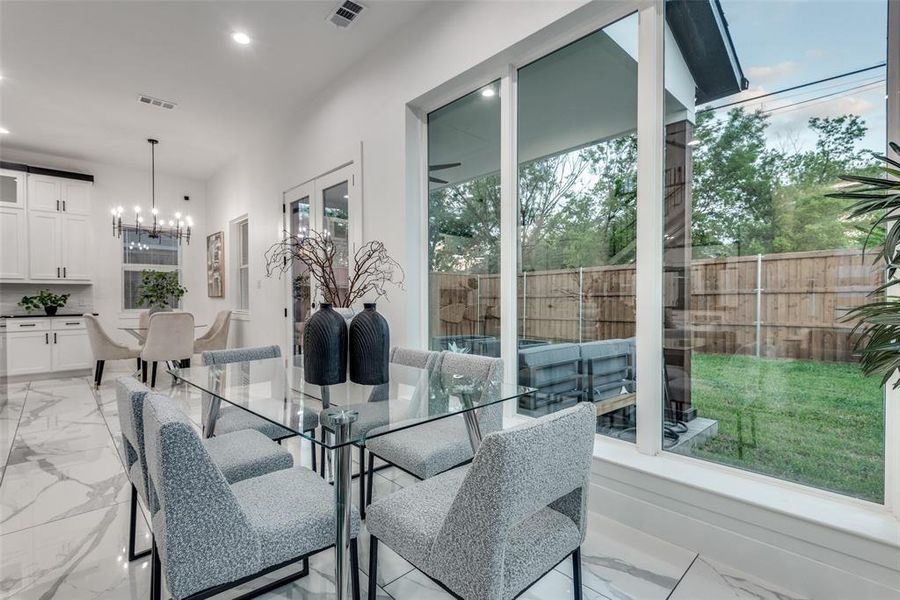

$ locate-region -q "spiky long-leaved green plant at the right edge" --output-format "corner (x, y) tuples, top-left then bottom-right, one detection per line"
(828, 142), (900, 388)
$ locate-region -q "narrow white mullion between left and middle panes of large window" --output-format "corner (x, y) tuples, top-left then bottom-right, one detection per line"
(500, 65), (519, 418)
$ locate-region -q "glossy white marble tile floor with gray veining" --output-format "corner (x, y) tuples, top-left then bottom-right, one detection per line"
(0, 363), (800, 600)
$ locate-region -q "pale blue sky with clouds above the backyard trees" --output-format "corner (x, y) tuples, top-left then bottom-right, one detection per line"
(712, 0), (887, 151)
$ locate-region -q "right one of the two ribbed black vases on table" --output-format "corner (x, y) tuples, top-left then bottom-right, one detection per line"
(350, 302), (391, 385)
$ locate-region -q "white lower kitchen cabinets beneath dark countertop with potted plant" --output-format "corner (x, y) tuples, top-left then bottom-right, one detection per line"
(5, 317), (93, 377)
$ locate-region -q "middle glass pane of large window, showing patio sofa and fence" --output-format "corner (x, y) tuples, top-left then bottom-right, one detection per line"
(517, 15), (638, 440)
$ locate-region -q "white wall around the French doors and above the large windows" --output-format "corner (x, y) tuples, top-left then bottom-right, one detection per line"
(200, 1), (584, 352)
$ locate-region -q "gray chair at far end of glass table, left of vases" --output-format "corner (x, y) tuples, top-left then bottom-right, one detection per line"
(200, 345), (319, 471)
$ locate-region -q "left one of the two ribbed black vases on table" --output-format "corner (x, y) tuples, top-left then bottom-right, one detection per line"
(303, 303), (347, 385)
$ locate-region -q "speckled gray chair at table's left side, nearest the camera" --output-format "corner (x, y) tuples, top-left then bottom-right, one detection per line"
(144, 393), (360, 600)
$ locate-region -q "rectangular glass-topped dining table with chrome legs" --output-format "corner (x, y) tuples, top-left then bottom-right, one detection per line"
(170, 358), (534, 600)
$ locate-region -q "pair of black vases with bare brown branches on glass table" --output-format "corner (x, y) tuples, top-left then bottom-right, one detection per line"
(266, 231), (404, 385)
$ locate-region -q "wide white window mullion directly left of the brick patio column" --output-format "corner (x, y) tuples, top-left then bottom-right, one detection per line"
(635, 0), (665, 455)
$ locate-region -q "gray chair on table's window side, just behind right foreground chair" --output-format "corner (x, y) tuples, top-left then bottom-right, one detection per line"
(366, 350), (503, 504)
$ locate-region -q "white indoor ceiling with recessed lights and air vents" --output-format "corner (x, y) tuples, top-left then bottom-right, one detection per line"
(0, 0), (436, 178)
